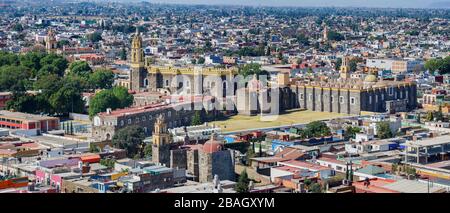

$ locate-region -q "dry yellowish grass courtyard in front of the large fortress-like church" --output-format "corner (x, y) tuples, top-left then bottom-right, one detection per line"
(212, 110), (351, 133)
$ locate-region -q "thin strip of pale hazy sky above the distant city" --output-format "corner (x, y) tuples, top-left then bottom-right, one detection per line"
(148, 0), (450, 8)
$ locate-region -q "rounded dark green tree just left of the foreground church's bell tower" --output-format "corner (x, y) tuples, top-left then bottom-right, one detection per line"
(112, 126), (145, 158)
